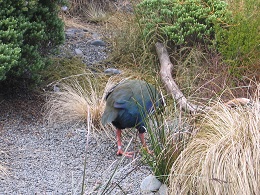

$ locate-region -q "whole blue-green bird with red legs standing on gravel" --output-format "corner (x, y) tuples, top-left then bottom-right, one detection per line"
(101, 79), (163, 157)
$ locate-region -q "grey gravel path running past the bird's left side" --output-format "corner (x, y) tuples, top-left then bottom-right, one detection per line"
(0, 25), (150, 195)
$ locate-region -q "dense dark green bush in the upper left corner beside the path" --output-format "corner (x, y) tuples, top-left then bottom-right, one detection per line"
(0, 0), (64, 81)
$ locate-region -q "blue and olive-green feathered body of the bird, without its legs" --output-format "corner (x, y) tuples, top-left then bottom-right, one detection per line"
(102, 80), (161, 129)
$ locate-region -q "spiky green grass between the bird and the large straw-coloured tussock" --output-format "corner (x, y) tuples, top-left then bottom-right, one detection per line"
(142, 104), (189, 183)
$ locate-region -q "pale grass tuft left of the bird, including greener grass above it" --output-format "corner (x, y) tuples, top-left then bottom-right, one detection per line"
(43, 76), (123, 137)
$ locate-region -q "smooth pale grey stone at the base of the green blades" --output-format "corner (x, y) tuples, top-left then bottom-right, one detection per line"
(140, 175), (162, 194)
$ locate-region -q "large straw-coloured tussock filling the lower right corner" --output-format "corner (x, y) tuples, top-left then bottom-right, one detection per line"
(170, 86), (260, 194)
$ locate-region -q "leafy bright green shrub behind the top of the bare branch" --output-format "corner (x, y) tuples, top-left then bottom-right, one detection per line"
(136, 0), (228, 45)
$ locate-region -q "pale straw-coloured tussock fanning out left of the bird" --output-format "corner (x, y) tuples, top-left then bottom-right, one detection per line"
(45, 79), (103, 125)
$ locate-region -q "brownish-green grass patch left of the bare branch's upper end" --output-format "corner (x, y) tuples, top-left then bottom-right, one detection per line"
(105, 8), (158, 79)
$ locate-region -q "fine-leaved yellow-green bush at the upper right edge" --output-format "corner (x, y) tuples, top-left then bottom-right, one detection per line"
(216, 0), (260, 76)
